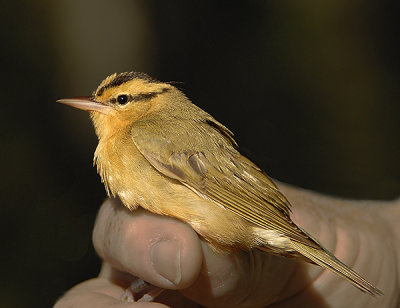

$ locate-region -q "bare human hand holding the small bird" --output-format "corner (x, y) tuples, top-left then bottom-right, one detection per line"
(55, 183), (400, 308)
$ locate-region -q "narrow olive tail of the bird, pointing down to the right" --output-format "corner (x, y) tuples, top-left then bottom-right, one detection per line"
(291, 240), (383, 296)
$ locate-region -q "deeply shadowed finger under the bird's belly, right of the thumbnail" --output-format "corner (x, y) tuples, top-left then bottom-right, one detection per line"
(182, 243), (303, 307)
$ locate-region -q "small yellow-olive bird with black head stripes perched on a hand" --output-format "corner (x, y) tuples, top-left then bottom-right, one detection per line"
(58, 72), (382, 295)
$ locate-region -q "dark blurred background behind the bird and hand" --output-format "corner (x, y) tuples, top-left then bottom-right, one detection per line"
(0, 0), (400, 307)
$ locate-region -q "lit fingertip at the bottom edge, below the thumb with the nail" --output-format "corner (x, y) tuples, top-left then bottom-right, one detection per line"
(54, 278), (167, 308)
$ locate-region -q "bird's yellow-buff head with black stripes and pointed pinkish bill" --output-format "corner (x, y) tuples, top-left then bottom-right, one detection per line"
(57, 72), (178, 138)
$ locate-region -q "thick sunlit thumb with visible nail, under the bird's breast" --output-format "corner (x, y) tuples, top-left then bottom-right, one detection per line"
(93, 199), (202, 289)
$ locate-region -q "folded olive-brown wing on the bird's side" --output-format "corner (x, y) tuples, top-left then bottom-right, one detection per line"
(131, 118), (318, 247)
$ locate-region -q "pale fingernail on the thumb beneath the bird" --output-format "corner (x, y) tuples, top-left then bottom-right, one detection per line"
(150, 240), (182, 285)
